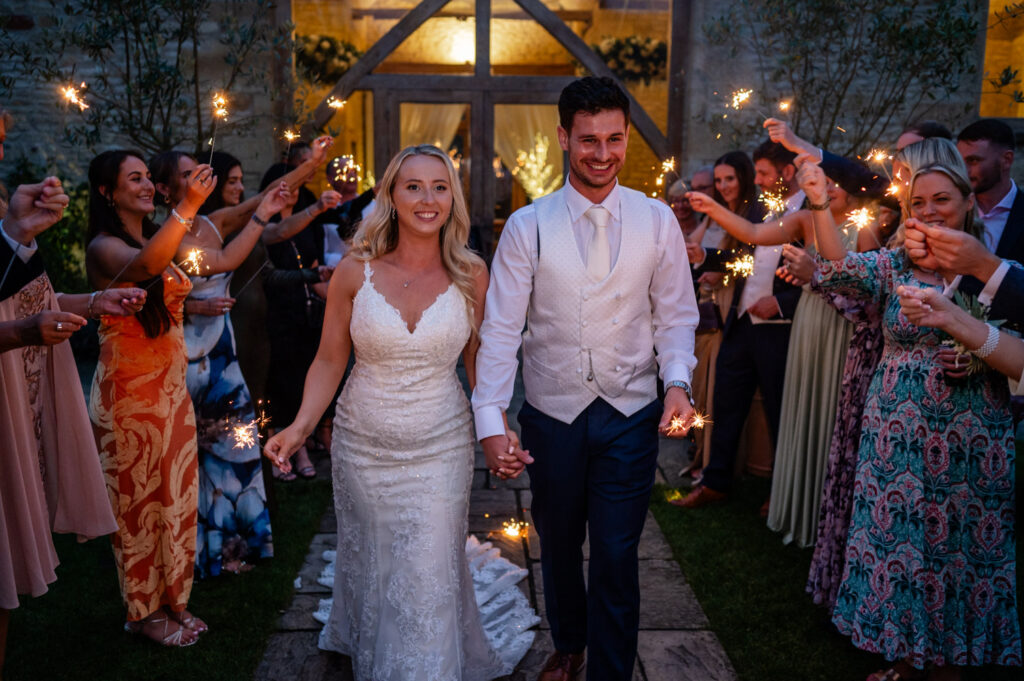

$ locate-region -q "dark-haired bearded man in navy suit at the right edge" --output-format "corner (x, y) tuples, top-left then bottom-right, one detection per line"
(956, 118), (1024, 261)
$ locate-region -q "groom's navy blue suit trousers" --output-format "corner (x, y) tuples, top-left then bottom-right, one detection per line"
(519, 398), (662, 681)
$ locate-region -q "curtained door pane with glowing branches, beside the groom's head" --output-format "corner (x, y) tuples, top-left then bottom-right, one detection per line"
(495, 104), (563, 199)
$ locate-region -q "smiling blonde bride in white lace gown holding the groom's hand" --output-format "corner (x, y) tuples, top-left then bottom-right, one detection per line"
(264, 145), (537, 681)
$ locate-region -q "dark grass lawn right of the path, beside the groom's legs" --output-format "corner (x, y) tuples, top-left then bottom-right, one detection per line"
(651, 478), (1021, 681)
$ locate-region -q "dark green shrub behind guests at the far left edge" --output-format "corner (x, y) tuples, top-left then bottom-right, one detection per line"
(6, 156), (89, 293)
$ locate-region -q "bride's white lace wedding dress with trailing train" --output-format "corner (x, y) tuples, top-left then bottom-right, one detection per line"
(319, 263), (538, 681)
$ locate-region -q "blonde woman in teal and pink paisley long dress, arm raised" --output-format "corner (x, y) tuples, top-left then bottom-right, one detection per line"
(800, 150), (1021, 681)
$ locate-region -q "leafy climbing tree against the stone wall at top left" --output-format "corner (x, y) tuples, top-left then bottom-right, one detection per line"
(0, 0), (291, 153)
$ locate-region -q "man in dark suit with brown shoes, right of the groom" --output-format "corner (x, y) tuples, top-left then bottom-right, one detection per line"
(676, 141), (805, 508)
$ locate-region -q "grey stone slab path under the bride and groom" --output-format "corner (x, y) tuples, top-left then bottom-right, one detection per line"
(256, 368), (736, 681)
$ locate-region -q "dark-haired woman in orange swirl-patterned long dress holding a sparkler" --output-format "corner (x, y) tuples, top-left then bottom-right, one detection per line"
(86, 151), (217, 646)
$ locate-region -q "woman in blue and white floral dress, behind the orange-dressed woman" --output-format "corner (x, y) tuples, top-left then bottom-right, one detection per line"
(177, 171), (289, 579)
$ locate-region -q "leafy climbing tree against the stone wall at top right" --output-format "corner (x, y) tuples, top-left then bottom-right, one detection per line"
(705, 0), (981, 153)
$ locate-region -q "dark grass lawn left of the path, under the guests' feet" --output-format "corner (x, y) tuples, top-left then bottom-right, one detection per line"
(4, 478), (331, 681)
